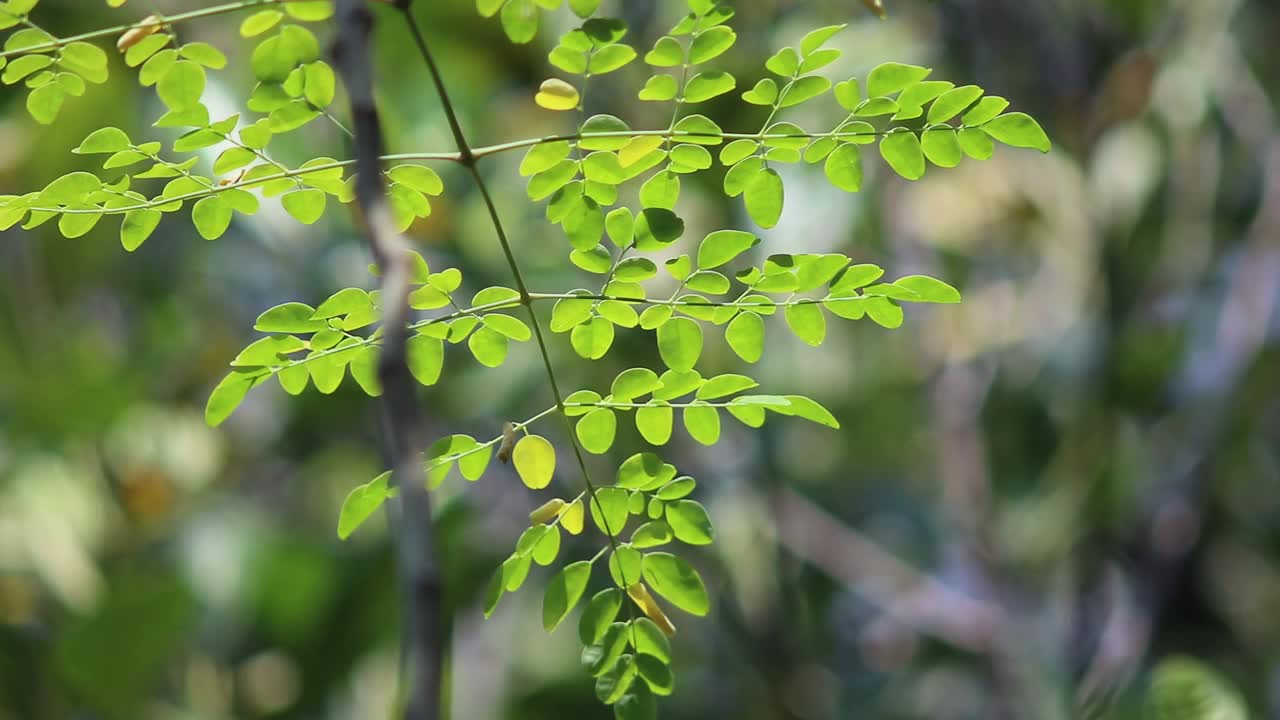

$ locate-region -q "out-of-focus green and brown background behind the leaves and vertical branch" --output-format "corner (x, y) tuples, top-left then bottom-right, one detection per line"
(0, 0), (1280, 720)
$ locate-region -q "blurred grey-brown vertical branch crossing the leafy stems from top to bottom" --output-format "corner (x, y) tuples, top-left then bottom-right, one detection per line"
(333, 0), (444, 720)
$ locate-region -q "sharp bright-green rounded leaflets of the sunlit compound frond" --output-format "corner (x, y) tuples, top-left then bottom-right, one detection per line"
(0, 0), (1054, 717)
